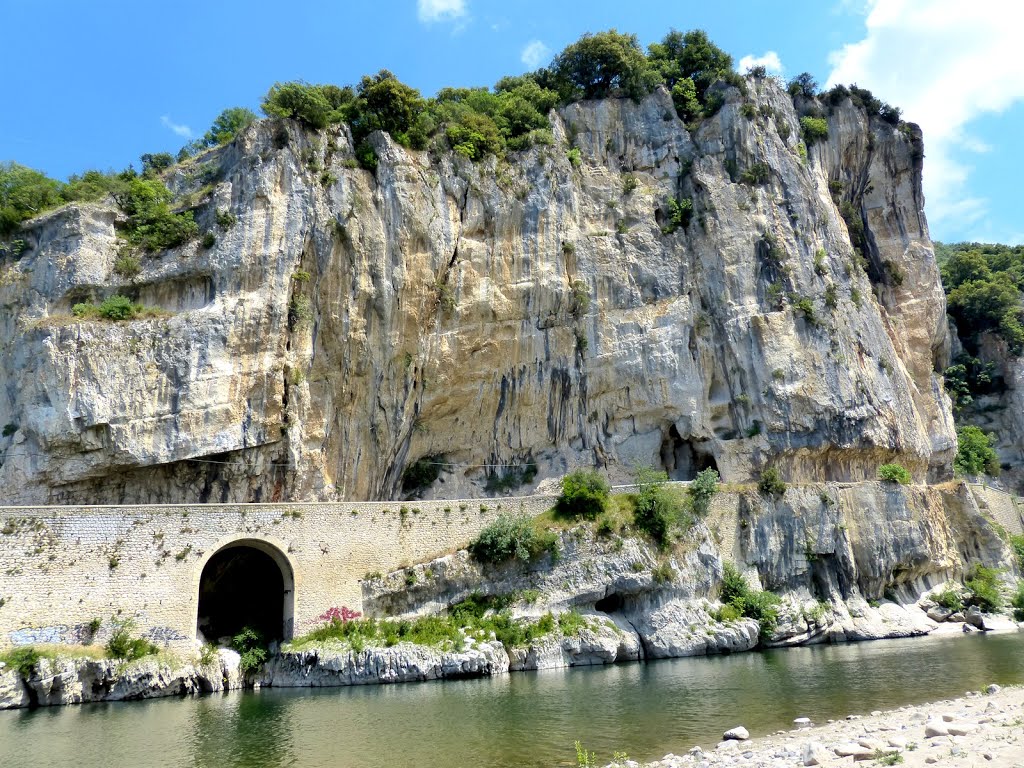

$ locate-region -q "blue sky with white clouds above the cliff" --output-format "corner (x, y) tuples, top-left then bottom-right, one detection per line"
(0, 0), (1024, 243)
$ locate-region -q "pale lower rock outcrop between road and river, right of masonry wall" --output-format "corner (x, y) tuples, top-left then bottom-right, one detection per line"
(364, 482), (1015, 666)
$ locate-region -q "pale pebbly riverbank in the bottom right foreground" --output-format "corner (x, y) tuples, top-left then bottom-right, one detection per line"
(630, 685), (1024, 768)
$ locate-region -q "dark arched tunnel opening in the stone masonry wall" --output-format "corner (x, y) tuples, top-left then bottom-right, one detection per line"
(196, 542), (294, 643)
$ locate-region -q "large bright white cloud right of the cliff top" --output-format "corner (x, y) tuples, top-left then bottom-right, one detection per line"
(826, 0), (1024, 229)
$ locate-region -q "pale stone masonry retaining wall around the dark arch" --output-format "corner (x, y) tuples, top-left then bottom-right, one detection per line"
(0, 496), (554, 648)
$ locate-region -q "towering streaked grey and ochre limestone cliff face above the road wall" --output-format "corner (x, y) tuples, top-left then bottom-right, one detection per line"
(0, 79), (954, 503)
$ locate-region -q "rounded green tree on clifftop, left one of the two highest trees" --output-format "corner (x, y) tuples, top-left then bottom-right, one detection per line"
(551, 30), (660, 101)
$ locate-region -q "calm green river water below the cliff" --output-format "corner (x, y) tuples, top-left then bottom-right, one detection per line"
(0, 633), (1024, 768)
